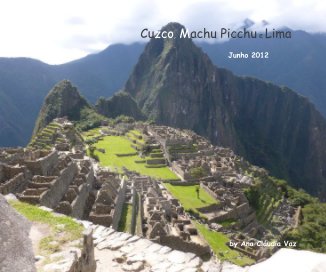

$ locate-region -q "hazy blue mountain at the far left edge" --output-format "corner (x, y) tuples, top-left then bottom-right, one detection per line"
(0, 58), (55, 146)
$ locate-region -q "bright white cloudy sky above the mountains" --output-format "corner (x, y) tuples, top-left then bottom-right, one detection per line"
(0, 0), (326, 64)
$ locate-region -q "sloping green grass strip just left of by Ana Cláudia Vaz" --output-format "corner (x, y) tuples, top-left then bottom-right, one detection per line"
(194, 222), (255, 266)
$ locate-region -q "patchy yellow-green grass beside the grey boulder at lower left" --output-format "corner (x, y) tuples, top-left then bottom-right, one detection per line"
(10, 201), (84, 255)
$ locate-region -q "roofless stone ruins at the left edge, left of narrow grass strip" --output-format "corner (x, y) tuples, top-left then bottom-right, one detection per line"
(0, 148), (126, 228)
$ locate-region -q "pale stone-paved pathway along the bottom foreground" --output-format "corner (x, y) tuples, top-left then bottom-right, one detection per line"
(80, 221), (246, 272)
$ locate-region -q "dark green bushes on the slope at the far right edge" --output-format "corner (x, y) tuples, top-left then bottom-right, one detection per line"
(245, 174), (326, 252)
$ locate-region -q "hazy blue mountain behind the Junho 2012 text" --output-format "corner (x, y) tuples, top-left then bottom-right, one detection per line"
(200, 31), (326, 116)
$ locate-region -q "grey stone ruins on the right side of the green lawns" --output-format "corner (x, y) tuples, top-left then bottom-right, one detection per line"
(147, 126), (300, 260)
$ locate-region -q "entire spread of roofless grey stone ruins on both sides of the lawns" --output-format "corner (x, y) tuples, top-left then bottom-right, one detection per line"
(0, 122), (300, 266)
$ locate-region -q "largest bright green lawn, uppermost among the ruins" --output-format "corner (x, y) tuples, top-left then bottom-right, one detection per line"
(94, 136), (178, 180)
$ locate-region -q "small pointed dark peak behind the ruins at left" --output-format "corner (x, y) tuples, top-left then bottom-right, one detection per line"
(33, 80), (103, 135)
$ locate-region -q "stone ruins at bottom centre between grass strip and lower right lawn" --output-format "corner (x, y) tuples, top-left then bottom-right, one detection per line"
(131, 174), (210, 256)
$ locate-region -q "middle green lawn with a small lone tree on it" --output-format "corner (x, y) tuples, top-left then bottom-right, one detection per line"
(164, 183), (218, 210)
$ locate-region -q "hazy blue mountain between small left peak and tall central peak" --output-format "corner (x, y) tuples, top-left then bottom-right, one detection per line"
(53, 43), (144, 103)
